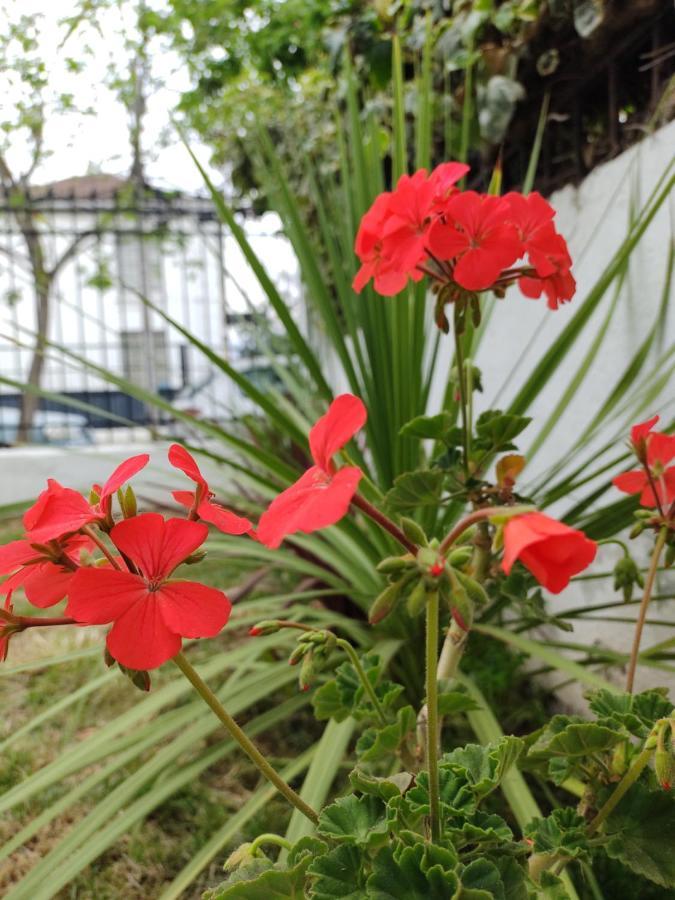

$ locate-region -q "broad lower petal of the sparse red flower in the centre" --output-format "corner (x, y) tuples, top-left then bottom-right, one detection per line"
(257, 466), (362, 548)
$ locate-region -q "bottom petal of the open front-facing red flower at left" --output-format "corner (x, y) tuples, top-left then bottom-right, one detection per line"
(106, 596), (182, 669)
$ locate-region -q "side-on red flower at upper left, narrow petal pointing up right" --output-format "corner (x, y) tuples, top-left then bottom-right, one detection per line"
(23, 453), (150, 543)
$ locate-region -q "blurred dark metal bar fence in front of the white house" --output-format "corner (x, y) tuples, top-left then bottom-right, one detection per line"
(0, 176), (292, 446)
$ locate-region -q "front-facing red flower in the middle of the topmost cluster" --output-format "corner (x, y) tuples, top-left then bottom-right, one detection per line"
(428, 191), (523, 291)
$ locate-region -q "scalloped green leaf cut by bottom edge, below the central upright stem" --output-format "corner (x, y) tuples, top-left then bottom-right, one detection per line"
(367, 844), (461, 900)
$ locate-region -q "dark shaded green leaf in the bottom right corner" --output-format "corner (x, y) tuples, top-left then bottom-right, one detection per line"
(604, 784), (675, 888)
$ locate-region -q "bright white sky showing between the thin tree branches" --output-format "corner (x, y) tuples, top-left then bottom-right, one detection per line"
(0, 0), (218, 191)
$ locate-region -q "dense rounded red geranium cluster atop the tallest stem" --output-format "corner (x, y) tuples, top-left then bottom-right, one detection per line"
(353, 163), (576, 309)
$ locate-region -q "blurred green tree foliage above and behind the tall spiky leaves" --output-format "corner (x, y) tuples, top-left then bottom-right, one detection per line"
(142, 0), (576, 213)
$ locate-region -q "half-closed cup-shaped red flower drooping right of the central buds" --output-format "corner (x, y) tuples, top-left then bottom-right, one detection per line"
(502, 512), (598, 594)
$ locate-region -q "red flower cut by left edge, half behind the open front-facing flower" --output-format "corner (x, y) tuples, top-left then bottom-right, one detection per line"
(0, 535), (93, 609)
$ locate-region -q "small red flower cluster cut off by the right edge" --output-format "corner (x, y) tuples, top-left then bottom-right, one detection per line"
(612, 416), (675, 509)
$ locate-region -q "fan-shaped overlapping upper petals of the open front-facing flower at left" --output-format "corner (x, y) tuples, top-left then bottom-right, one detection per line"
(110, 513), (209, 581)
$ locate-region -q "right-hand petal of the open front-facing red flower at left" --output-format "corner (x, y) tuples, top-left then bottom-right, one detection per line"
(155, 581), (232, 638)
